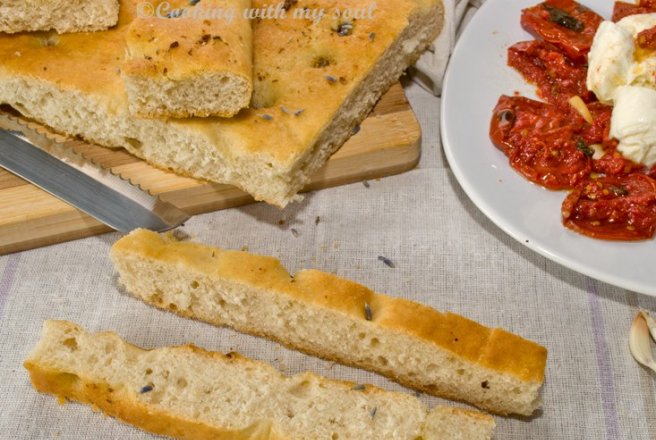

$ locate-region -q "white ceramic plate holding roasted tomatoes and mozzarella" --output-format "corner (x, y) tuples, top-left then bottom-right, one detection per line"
(441, 0), (656, 296)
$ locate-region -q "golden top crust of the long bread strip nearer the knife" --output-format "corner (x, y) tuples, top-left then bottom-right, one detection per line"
(112, 230), (547, 386)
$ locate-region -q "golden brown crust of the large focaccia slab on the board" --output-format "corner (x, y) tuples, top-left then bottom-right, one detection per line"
(0, 0), (443, 206)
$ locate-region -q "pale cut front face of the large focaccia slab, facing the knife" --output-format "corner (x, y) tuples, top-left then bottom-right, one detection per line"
(0, 78), (289, 207)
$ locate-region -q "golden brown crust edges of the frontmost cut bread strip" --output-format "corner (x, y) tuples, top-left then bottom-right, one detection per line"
(24, 321), (494, 440)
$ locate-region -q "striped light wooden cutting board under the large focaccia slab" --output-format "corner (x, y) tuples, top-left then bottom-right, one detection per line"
(0, 85), (421, 255)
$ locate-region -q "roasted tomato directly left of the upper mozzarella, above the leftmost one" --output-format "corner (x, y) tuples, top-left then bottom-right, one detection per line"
(508, 40), (596, 105)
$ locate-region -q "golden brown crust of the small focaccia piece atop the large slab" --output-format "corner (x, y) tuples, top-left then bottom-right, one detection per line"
(121, 0), (253, 118)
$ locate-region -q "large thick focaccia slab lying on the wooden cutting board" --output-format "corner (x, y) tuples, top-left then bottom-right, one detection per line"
(0, 0), (444, 207)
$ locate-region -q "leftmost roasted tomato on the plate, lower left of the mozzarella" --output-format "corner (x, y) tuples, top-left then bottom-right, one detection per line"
(490, 96), (592, 189)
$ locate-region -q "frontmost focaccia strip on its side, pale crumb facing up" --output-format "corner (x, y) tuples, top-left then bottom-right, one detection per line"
(25, 321), (494, 440)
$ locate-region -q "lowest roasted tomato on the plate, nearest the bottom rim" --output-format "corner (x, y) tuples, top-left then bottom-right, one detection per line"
(562, 173), (656, 240)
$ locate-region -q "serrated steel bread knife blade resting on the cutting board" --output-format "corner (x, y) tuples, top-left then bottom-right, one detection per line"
(0, 116), (190, 233)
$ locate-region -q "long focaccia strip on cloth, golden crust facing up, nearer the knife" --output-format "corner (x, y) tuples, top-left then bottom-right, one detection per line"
(111, 230), (547, 415)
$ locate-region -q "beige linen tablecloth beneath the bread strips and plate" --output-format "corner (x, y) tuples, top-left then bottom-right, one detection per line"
(0, 1), (656, 440)
